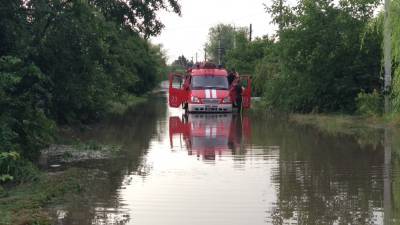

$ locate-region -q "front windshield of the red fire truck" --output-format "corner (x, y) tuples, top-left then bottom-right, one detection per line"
(192, 76), (228, 90)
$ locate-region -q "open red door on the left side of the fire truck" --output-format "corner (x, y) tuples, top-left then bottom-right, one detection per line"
(168, 74), (186, 108)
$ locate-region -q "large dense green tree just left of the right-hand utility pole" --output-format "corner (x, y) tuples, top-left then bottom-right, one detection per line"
(264, 0), (382, 112)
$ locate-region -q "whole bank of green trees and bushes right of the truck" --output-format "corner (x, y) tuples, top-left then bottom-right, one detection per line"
(202, 0), (400, 125)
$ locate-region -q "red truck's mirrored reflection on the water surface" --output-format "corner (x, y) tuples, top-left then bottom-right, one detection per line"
(169, 114), (251, 159)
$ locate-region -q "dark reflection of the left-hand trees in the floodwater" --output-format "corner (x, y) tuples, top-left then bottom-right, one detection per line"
(52, 96), (165, 225)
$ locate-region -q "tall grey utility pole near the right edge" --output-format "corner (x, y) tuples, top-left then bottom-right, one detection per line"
(383, 0), (392, 113)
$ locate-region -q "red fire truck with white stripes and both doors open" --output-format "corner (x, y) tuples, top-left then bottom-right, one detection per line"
(169, 64), (251, 113)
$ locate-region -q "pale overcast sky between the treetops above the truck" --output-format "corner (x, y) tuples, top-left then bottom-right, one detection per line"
(152, 0), (275, 62)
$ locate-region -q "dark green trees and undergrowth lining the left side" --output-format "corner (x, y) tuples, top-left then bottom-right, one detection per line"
(0, 0), (180, 224)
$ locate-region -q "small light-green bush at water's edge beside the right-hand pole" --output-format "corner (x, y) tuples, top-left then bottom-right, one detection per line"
(356, 90), (383, 116)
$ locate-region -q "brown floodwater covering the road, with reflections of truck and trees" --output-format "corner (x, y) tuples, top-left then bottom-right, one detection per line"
(49, 93), (400, 225)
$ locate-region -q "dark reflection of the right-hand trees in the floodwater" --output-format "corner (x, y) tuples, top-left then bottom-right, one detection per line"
(252, 115), (384, 224)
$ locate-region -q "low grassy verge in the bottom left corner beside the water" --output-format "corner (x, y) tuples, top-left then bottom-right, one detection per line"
(0, 169), (83, 225)
